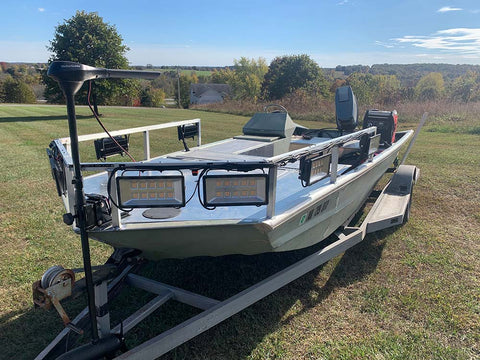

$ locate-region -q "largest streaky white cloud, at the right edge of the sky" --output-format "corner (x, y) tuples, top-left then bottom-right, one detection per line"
(393, 28), (480, 54)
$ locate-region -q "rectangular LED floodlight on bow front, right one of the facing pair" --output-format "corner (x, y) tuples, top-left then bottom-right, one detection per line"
(203, 174), (268, 206)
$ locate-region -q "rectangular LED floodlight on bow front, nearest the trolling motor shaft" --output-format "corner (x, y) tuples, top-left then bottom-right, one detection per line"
(117, 176), (185, 208)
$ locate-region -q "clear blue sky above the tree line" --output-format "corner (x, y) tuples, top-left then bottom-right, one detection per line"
(0, 0), (480, 67)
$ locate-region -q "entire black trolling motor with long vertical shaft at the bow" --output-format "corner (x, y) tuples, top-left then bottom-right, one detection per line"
(37, 61), (160, 359)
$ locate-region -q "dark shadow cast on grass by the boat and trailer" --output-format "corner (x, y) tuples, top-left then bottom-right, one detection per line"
(0, 232), (394, 360)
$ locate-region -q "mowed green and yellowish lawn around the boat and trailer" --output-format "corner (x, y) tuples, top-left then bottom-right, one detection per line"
(0, 105), (480, 359)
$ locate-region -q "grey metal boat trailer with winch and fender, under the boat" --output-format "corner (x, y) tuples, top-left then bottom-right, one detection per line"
(34, 165), (419, 360)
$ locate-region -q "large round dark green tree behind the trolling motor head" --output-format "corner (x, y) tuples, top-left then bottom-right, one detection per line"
(44, 11), (136, 110)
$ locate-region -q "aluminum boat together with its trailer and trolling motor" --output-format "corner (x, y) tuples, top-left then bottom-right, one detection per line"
(32, 61), (420, 360)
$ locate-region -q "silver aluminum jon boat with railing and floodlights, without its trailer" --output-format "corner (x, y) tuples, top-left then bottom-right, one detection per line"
(47, 62), (413, 260)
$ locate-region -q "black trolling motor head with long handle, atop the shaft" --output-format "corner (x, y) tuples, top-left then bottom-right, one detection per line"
(47, 61), (160, 95)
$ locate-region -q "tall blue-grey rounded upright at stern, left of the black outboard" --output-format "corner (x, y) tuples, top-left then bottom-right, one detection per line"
(335, 86), (358, 131)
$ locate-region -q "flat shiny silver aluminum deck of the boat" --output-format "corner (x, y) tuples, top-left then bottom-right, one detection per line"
(84, 137), (349, 224)
